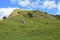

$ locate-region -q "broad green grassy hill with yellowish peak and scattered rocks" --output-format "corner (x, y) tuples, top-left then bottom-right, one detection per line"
(0, 9), (60, 40)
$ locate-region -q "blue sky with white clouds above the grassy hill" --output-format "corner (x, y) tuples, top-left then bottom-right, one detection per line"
(0, 0), (60, 18)
